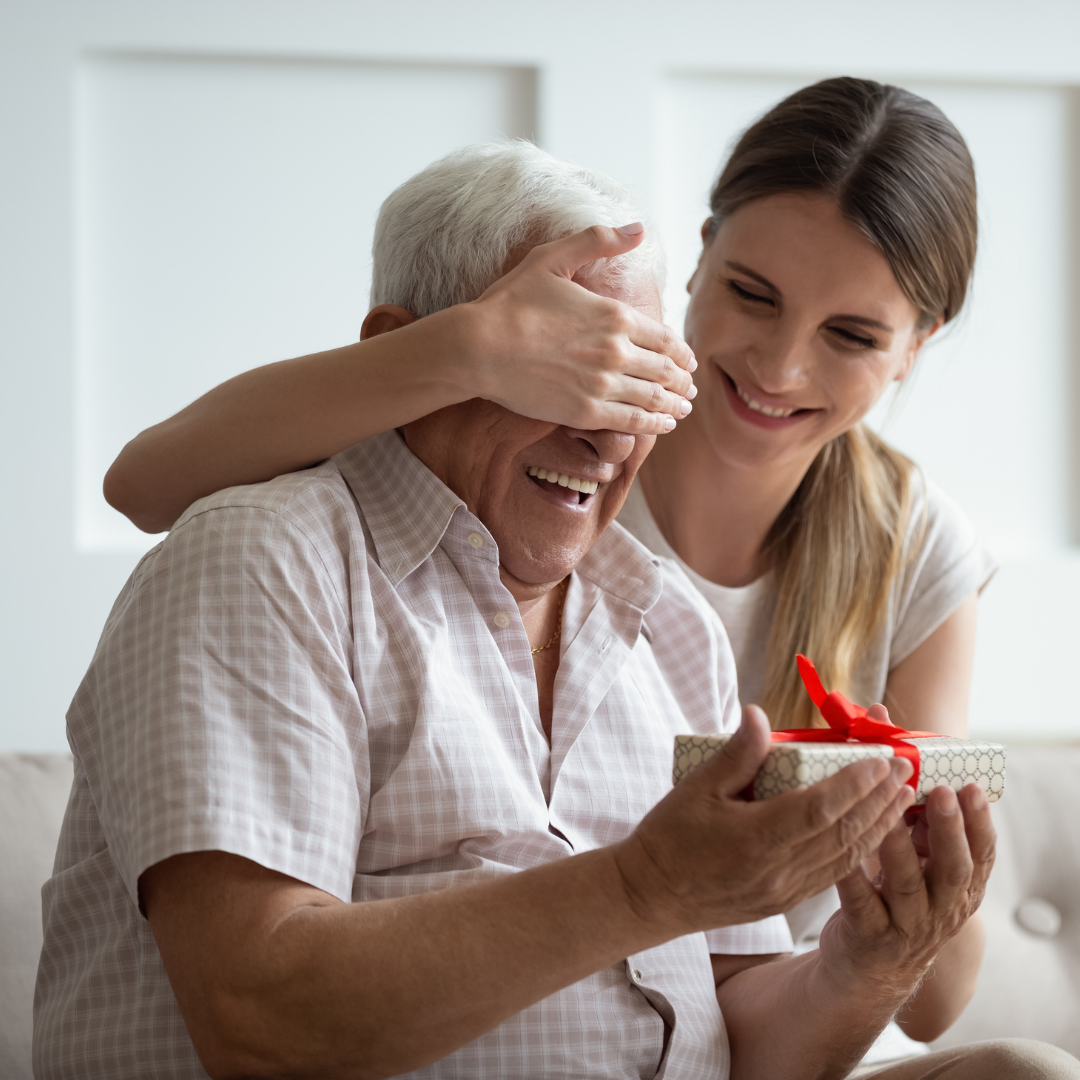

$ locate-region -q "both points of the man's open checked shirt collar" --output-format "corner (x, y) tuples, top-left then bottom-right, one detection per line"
(334, 431), (662, 612)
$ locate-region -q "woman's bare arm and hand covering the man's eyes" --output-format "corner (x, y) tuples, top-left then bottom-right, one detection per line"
(105, 227), (696, 532)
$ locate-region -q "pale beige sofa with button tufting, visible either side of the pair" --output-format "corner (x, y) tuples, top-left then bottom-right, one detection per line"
(0, 746), (1080, 1080)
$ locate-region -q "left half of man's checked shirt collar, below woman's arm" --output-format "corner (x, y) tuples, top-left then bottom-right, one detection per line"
(334, 431), (464, 585)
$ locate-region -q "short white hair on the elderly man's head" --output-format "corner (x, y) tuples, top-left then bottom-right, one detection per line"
(372, 139), (664, 318)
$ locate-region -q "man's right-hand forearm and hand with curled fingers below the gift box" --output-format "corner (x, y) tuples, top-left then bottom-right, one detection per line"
(708, 705), (994, 1080)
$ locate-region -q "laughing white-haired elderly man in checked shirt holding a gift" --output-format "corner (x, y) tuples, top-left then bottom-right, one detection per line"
(35, 145), (1010, 1080)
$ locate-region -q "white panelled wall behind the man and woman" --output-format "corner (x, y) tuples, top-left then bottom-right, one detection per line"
(0, 0), (1080, 750)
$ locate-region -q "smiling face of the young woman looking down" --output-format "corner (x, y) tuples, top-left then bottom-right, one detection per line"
(686, 193), (940, 470)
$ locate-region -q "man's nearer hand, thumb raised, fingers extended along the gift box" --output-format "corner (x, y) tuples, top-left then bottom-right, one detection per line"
(618, 705), (915, 933)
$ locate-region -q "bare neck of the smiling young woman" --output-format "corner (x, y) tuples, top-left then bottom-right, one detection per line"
(639, 414), (812, 588)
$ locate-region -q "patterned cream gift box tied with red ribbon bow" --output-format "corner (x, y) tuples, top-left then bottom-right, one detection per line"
(672, 656), (1005, 806)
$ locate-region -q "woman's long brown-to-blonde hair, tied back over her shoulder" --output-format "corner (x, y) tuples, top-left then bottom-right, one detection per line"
(705, 79), (977, 727)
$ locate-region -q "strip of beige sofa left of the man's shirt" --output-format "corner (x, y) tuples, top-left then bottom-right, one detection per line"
(0, 754), (71, 1080)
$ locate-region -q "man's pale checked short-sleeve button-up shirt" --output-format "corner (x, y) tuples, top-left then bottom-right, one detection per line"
(35, 432), (791, 1080)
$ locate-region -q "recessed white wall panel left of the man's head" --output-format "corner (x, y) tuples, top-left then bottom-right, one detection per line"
(76, 55), (536, 551)
